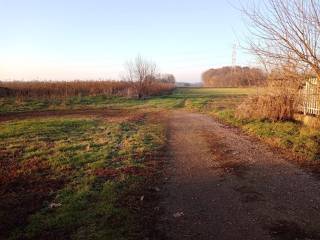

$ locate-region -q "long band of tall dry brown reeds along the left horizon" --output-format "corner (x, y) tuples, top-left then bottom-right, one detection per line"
(0, 81), (174, 99)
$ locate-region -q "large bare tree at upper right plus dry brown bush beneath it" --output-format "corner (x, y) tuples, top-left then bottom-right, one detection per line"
(237, 0), (320, 120)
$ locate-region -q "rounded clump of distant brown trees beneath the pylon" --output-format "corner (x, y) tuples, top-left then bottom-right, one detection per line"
(202, 66), (267, 87)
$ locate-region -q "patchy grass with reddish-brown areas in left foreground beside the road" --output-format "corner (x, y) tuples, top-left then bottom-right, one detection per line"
(0, 118), (165, 239)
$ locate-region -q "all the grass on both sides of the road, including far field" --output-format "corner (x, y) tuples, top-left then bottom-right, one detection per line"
(0, 88), (320, 239)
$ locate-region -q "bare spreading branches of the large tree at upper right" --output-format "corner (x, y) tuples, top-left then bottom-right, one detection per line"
(242, 0), (320, 81)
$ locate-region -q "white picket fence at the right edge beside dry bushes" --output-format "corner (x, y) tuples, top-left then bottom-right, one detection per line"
(302, 78), (320, 116)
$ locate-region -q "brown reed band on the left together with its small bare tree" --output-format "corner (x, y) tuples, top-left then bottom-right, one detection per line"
(0, 56), (175, 99)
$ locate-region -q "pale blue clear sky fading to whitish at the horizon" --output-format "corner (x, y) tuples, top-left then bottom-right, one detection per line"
(0, 0), (254, 82)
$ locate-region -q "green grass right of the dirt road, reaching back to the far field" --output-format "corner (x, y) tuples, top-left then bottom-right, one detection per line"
(168, 88), (320, 160)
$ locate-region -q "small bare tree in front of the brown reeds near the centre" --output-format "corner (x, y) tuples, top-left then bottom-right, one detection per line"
(125, 55), (157, 99)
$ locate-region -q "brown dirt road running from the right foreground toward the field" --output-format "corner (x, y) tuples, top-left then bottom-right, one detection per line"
(158, 111), (320, 240)
